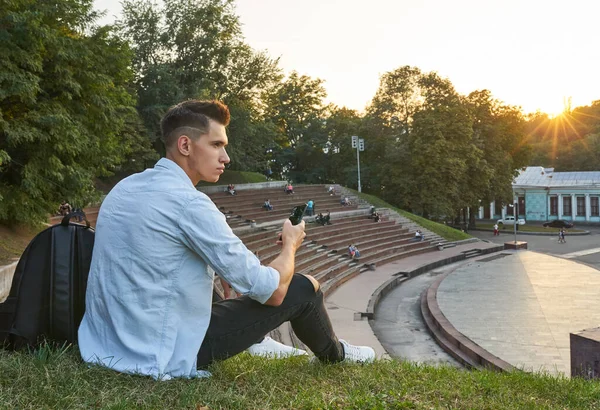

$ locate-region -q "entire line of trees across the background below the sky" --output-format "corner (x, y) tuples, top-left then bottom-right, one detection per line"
(0, 0), (600, 223)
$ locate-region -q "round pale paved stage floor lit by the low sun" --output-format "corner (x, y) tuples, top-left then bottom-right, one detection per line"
(437, 251), (600, 376)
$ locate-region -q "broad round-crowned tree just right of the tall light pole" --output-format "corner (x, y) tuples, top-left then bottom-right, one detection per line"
(368, 67), (480, 217)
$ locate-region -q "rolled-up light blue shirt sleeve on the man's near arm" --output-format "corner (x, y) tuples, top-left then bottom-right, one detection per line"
(179, 194), (280, 303)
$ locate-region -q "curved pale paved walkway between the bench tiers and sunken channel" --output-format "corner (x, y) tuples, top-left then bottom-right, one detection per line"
(325, 242), (495, 357)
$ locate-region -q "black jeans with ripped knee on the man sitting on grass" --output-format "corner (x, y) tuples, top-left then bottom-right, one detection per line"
(197, 274), (344, 368)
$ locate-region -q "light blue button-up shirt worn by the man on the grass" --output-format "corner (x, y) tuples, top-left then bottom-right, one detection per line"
(79, 158), (279, 380)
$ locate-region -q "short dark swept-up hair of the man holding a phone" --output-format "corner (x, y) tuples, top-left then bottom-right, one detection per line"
(160, 100), (230, 147)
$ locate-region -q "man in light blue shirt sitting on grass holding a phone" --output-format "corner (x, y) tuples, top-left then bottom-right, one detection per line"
(79, 101), (375, 380)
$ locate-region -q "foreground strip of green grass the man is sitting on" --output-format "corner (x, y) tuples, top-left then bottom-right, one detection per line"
(0, 346), (600, 410)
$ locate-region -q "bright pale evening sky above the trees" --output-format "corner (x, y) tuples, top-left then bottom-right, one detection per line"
(95, 0), (600, 115)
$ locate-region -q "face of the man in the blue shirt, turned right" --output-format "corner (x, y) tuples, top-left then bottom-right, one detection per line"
(188, 120), (229, 184)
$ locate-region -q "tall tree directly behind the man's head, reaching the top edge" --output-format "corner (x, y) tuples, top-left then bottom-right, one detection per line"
(120, 0), (282, 170)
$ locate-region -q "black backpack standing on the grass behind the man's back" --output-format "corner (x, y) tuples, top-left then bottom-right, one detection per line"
(0, 212), (94, 349)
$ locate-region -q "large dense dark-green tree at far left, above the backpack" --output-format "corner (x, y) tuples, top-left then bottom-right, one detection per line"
(0, 0), (150, 223)
